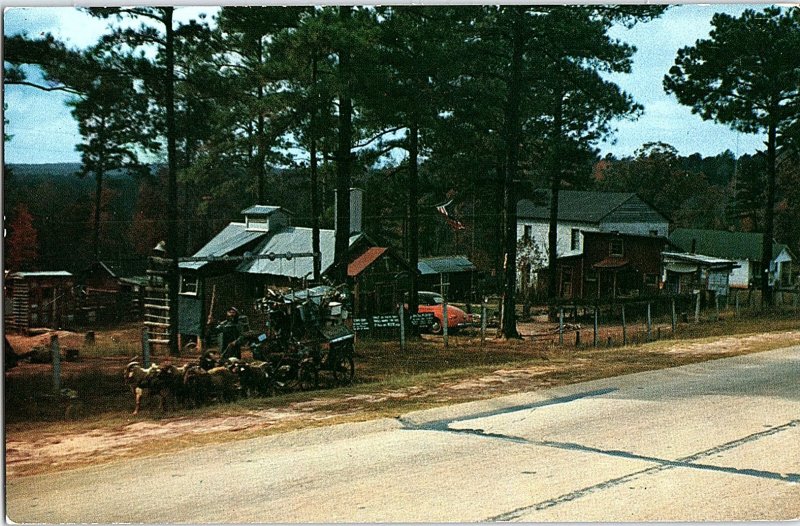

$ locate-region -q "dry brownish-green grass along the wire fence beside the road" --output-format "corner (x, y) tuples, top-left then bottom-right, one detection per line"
(5, 312), (800, 426)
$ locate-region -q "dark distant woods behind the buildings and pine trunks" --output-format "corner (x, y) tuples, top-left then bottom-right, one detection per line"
(3, 150), (800, 284)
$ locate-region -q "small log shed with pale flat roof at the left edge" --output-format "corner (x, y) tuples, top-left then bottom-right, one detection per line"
(4, 270), (75, 333)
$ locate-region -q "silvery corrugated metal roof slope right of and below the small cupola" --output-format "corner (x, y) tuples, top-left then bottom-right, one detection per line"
(236, 230), (361, 278)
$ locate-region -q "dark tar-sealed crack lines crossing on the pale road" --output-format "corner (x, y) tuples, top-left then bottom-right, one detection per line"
(398, 389), (800, 522)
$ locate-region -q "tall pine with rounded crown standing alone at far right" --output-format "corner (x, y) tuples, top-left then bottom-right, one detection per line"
(664, 7), (800, 305)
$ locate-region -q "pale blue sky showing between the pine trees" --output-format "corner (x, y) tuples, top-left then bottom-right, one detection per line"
(3, 4), (776, 163)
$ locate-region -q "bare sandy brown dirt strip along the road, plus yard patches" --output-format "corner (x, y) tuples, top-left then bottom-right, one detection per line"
(5, 327), (800, 477)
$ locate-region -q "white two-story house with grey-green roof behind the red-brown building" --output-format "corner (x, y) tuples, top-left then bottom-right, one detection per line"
(517, 190), (669, 283)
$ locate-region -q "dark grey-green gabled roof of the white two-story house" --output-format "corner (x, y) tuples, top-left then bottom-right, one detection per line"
(517, 190), (668, 224)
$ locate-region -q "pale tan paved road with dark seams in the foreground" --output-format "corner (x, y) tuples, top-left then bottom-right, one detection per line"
(6, 347), (800, 523)
